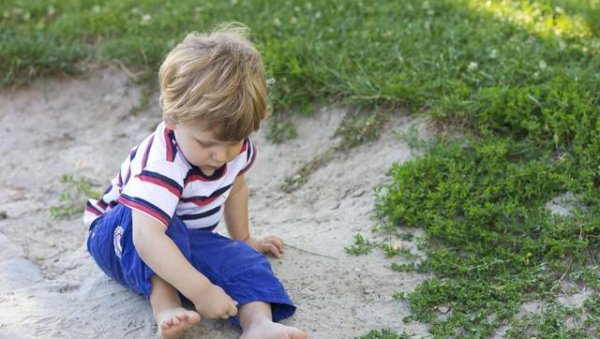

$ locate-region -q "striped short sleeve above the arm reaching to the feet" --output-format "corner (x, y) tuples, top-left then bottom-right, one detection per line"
(119, 161), (184, 227)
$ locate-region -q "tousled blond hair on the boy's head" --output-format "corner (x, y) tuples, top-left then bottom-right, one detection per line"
(158, 24), (270, 141)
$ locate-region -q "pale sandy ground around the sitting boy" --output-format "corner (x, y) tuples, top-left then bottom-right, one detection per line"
(0, 70), (427, 339)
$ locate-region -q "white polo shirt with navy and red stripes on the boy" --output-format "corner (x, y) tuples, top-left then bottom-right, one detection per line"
(84, 122), (257, 231)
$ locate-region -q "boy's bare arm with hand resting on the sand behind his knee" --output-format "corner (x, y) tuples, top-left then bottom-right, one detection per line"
(224, 175), (283, 257)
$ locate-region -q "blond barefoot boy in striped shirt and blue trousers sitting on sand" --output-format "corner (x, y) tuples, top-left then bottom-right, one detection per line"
(84, 26), (306, 339)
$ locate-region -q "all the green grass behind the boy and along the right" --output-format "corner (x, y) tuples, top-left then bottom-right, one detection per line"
(0, 0), (600, 338)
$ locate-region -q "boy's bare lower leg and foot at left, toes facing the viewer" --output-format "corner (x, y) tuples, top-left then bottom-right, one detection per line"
(150, 275), (200, 338)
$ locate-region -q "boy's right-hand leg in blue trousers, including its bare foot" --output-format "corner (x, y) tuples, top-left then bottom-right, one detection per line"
(190, 231), (306, 339)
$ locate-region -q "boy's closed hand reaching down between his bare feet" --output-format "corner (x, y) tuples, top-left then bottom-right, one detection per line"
(192, 284), (237, 319)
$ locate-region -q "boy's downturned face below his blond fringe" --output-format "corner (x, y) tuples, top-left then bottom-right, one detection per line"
(170, 123), (244, 175)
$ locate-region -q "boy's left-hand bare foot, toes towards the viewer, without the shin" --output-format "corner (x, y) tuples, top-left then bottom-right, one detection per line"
(155, 307), (200, 339)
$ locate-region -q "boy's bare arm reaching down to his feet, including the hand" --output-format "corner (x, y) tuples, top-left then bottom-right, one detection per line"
(132, 210), (237, 319)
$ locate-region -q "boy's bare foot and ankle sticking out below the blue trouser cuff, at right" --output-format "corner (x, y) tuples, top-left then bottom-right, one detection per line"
(239, 301), (306, 339)
